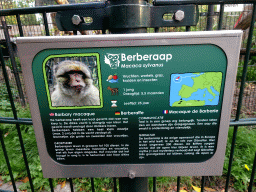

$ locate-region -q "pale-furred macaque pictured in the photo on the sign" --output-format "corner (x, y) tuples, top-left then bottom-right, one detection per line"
(51, 60), (100, 107)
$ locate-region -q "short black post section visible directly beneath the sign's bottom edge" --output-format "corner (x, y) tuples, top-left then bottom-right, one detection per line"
(119, 177), (148, 192)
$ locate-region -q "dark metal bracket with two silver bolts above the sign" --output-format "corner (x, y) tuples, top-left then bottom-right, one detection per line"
(56, 1), (199, 31)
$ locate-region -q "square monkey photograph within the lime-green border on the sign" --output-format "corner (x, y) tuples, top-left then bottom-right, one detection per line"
(45, 56), (101, 107)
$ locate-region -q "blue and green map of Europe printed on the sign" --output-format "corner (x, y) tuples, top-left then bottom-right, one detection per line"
(170, 72), (222, 107)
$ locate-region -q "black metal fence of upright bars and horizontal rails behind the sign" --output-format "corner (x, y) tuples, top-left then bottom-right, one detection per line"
(0, 0), (256, 192)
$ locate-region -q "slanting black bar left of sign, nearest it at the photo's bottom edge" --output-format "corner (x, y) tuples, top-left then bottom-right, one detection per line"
(0, 44), (34, 192)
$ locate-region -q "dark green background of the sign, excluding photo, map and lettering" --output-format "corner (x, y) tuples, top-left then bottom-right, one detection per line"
(32, 45), (227, 164)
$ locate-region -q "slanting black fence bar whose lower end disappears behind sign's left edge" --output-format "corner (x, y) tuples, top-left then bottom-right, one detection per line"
(1, 17), (26, 106)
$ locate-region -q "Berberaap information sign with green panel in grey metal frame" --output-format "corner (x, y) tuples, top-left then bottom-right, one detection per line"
(17, 31), (242, 178)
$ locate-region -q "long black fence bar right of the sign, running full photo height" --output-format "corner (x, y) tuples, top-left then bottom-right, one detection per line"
(225, 3), (256, 192)
